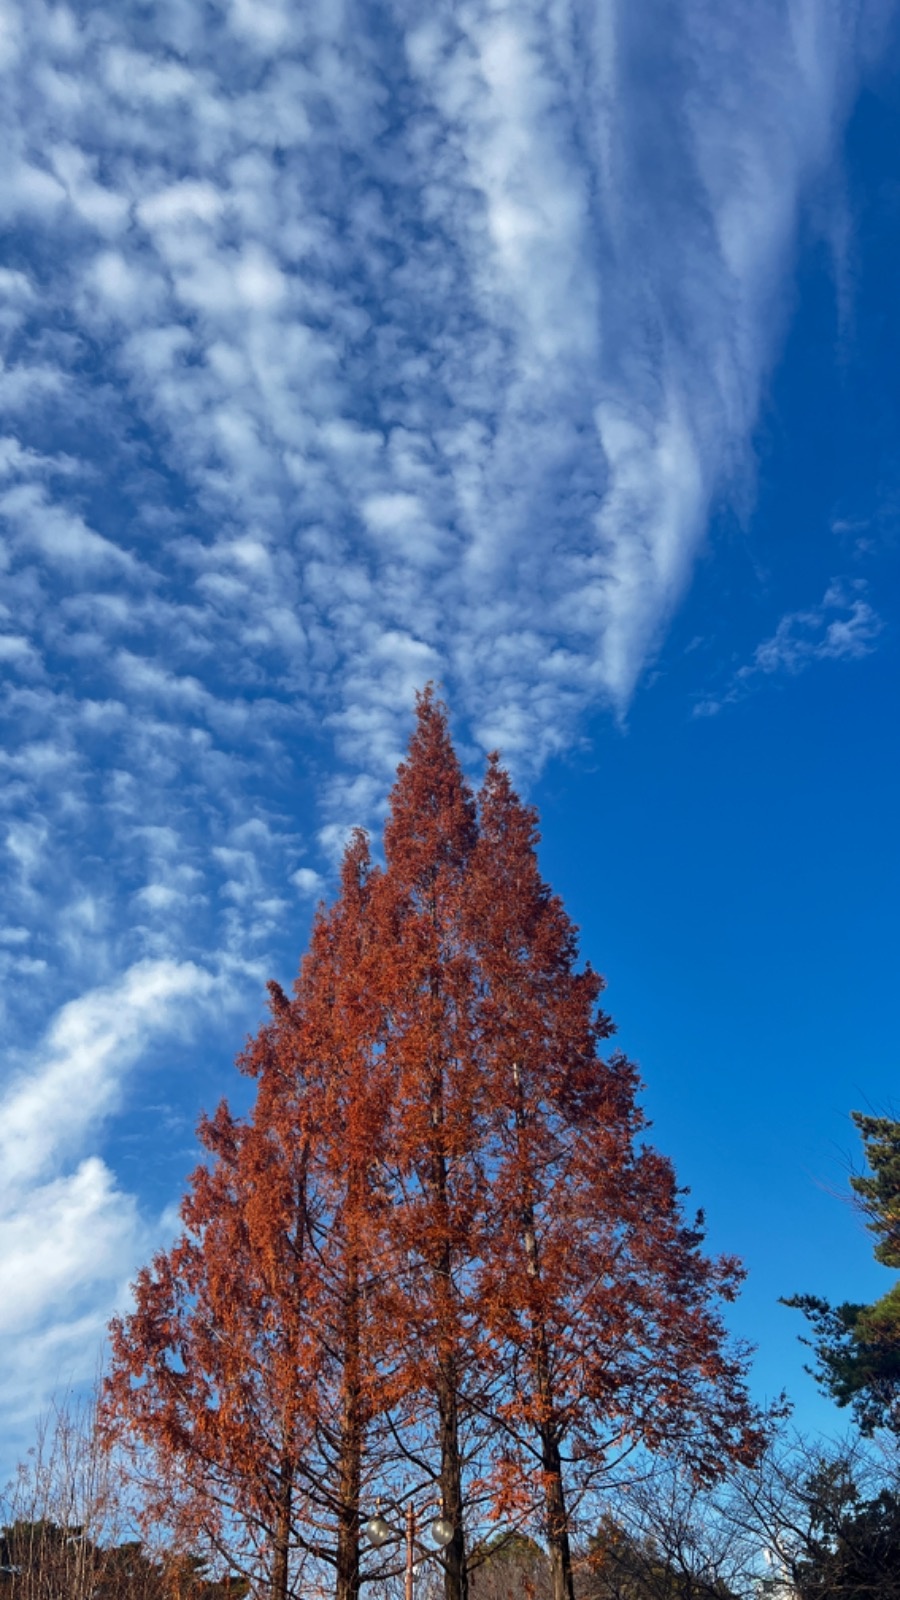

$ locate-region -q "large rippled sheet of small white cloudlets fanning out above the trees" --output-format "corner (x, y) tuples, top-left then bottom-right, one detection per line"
(0, 0), (894, 1452)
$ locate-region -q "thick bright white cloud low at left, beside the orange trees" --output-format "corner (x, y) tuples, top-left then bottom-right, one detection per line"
(0, 953), (215, 1424)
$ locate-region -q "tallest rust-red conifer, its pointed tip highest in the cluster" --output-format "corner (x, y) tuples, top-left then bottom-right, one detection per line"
(373, 691), (480, 1600)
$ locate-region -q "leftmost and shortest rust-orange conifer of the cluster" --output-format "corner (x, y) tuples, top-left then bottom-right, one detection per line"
(102, 998), (322, 1600)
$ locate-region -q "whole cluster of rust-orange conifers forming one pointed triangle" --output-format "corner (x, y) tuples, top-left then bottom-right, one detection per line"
(106, 691), (764, 1600)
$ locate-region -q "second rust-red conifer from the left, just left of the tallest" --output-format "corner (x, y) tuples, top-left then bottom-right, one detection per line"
(280, 832), (392, 1600)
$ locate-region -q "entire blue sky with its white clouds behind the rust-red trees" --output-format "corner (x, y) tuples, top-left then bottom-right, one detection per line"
(0, 0), (900, 1472)
